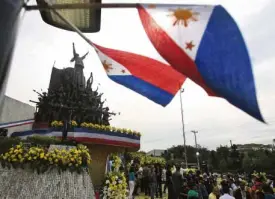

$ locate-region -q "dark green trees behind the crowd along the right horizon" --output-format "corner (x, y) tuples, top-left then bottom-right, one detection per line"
(163, 144), (275, 174)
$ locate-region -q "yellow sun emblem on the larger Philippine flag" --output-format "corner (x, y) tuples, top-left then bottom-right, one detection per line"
(169, 8), (199, 27)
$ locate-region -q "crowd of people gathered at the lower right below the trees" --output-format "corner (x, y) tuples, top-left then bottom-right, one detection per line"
(128, 164), (275, 199)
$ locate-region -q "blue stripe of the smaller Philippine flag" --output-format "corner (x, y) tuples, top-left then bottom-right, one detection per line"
(109, 75), (174, 106)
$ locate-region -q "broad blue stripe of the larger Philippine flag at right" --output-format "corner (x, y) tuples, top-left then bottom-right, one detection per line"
(195, 6), (264, 121)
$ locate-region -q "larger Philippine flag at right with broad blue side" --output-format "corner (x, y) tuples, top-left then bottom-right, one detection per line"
(138, 4), (264, 122)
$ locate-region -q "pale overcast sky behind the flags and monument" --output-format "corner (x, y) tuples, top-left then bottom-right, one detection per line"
(4, 0), (275, 151)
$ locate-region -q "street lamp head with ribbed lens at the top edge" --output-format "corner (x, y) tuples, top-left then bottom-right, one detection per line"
(36, 0), (101, 33)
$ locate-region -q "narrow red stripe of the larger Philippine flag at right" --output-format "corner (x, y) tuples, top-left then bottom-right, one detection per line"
(138, 5), (216, 96)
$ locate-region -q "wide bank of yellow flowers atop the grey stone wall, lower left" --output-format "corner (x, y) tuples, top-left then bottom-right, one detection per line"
(0, 144), (91, 173)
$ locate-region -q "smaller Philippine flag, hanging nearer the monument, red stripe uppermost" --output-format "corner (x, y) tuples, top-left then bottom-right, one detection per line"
(90, 42), (186, 106)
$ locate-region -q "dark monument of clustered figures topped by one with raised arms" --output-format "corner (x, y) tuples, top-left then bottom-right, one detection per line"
(31, 44), (115, 127)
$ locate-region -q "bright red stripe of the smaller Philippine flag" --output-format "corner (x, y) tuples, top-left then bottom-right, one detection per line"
(93, 43), (186, 95)
